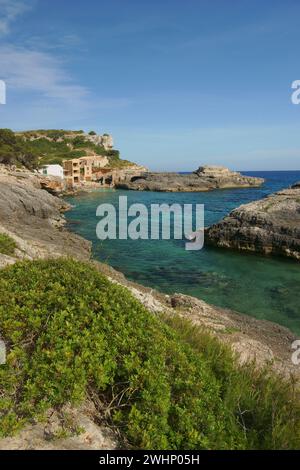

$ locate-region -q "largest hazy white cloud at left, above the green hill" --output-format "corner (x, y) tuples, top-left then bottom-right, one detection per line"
(0, 45), (132, 129)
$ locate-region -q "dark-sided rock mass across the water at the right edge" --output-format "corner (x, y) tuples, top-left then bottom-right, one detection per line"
(205, 183), (300, 260)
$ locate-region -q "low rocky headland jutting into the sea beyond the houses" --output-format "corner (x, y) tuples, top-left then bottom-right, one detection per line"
(116, 166), (264, 192)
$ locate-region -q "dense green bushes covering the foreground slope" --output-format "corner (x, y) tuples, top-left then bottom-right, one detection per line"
(0, 259), (300, 449)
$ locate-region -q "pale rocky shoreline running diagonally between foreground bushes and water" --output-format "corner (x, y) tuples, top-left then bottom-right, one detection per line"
(0, 164), (299, 373)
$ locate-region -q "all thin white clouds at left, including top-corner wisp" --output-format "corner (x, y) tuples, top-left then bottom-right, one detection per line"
(0, 0), (131, 128)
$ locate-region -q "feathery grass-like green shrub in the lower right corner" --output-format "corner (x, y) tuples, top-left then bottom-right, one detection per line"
(165, 317), (300, 449)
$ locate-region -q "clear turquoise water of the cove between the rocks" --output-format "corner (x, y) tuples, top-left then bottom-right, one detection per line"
(66, 172), (300, 334)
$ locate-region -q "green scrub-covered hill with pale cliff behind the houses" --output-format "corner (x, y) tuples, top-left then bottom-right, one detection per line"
(0, 129), (120, 169)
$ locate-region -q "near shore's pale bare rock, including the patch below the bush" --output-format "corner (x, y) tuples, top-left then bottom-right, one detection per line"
(0, 164), (300, 450)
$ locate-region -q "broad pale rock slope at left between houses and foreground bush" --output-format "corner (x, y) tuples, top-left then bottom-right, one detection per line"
(0, 168), (90, 266)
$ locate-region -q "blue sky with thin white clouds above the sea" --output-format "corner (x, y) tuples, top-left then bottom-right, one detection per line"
(0, 0), (300, 171)
